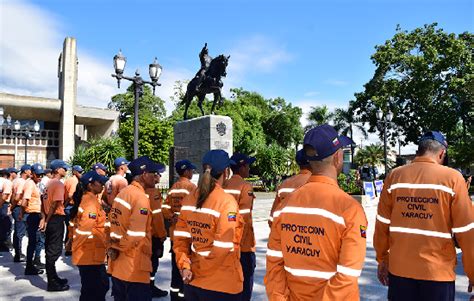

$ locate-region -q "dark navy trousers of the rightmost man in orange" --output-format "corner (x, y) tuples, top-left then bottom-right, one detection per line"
(388, 274), (455, 301)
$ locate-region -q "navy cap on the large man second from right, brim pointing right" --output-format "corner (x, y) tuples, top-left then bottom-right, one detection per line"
(303, 124), (355, 161)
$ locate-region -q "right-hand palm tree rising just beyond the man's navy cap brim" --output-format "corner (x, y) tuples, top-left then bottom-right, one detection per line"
(332, 102), (368, 162)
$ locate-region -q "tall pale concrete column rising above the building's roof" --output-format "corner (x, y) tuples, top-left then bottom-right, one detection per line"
(58, 37), (77, 160)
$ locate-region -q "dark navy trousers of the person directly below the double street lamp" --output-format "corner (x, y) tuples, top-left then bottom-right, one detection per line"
(112, 277), (151, 301)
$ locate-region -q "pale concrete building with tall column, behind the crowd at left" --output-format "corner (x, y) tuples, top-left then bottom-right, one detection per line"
(0, 37), (119, 168)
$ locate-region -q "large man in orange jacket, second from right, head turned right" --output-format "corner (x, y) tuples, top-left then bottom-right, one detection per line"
(265, 124), (367, 301)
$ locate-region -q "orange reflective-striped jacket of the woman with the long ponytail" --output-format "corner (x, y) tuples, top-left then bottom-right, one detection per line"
(173, 184), (244, 294)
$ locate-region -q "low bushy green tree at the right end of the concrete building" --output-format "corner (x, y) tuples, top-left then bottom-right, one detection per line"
(69, 137), (127, 171)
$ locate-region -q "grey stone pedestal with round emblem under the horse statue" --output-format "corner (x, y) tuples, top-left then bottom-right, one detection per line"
(174, 115), (233, 179)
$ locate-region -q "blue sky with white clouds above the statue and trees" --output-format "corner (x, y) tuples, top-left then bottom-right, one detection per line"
(0, 0), (474, 150)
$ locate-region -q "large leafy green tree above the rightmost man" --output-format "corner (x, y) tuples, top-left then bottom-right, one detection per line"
(354, 23), (474, 165)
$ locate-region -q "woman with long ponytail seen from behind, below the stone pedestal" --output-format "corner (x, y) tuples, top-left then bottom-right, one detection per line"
(173, 150), (243, 301)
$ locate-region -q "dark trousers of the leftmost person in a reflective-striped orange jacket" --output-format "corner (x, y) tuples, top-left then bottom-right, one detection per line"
(77, 264), (109, 301)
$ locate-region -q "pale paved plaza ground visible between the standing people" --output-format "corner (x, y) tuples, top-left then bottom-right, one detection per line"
(0, 194), (469, 301)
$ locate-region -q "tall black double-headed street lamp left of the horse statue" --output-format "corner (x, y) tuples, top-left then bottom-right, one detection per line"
(112, 50), (163, 159)
